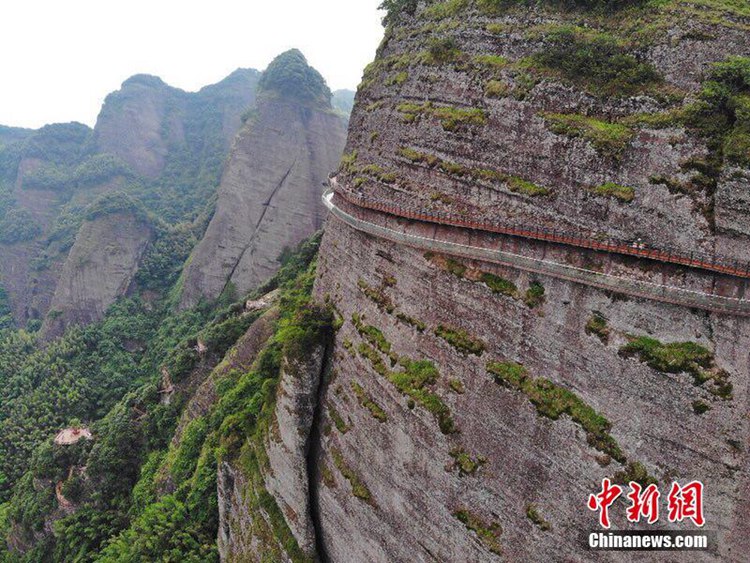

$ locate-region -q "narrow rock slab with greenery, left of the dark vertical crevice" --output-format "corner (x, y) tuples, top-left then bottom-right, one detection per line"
(218, 344), (325, 563)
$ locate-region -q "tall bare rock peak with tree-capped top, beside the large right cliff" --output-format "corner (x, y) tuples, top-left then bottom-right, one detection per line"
(182, 50), (345, 307)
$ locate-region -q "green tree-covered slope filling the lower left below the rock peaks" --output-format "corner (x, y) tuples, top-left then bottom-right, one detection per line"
(0, 231), (331, 563)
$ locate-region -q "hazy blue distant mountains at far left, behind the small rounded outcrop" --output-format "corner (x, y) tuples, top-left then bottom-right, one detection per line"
(0, 69), (260, 327)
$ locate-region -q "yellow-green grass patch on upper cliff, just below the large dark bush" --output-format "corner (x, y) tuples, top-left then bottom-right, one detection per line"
(542, 113), (635, 159)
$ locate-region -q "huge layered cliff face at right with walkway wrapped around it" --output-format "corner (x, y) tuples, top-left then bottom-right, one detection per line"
(304, 2), (750, 561)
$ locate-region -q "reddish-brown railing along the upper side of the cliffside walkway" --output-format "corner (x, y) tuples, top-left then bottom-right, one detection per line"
(331, 178), (750, 278)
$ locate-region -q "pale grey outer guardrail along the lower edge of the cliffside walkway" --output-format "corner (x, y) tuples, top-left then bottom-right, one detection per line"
(323, 189), (750, 317)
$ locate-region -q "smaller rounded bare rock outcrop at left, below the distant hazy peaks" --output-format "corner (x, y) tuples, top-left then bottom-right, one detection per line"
(43, 212), (154, 338)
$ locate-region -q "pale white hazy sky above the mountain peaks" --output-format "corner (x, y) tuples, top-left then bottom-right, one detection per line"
(0, 0), (383, 127)
